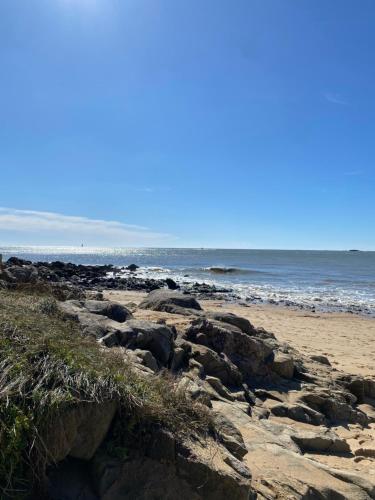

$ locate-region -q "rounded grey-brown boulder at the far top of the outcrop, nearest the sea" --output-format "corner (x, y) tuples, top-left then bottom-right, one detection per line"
(139, 290), (202, 315)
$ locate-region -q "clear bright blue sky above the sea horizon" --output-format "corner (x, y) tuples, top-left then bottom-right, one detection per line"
(0, 0), (375, 250)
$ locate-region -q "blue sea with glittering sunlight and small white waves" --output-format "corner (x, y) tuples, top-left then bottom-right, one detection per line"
(0, 247), (375, 314)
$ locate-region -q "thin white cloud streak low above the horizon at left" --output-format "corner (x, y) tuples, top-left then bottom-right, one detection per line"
(0, 207), (173, 245)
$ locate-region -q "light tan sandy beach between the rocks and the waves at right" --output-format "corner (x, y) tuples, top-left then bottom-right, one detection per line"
(105, 291), (375, 376)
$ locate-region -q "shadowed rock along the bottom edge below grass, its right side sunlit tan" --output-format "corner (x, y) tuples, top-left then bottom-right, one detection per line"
(48, 430), (254, 500)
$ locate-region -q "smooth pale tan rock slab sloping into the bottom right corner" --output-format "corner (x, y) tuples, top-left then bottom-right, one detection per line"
(212, 401), (374, 500)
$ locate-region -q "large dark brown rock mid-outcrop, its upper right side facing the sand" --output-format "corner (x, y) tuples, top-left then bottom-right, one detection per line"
(186, 319), (273, 378)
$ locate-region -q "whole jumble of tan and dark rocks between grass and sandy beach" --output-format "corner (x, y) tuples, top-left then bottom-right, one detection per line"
(42, 290), (375, 500)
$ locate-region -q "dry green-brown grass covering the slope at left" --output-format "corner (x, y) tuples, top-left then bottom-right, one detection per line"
(0, 291), (212, 499)
